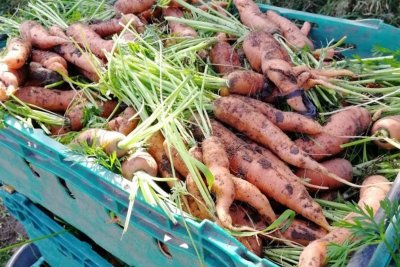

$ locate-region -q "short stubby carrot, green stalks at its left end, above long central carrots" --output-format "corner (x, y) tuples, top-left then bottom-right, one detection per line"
(225, 70), (268, 95)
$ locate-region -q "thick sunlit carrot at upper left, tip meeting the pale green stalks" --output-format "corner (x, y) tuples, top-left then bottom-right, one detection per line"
(67, 23), (114, 59)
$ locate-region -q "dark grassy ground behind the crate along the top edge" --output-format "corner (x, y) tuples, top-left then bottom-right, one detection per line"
(0, 0), (400, 26)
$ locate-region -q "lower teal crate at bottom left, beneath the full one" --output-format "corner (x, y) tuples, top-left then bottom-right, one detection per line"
(0, 190), (112, 267)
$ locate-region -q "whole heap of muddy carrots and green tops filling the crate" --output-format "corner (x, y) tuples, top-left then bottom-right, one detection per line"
(0, 0), (400, 266)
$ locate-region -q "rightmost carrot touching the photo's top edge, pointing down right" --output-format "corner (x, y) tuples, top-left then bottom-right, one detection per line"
(233, 0), (279, 34)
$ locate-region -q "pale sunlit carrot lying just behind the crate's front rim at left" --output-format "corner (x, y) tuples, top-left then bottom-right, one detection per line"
(73, 128), (128, 157)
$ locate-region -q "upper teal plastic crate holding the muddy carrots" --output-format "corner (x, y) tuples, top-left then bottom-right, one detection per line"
(0, 5), (400, 266)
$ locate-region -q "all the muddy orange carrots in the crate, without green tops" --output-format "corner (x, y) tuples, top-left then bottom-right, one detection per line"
(0, 0), (400, 266)
